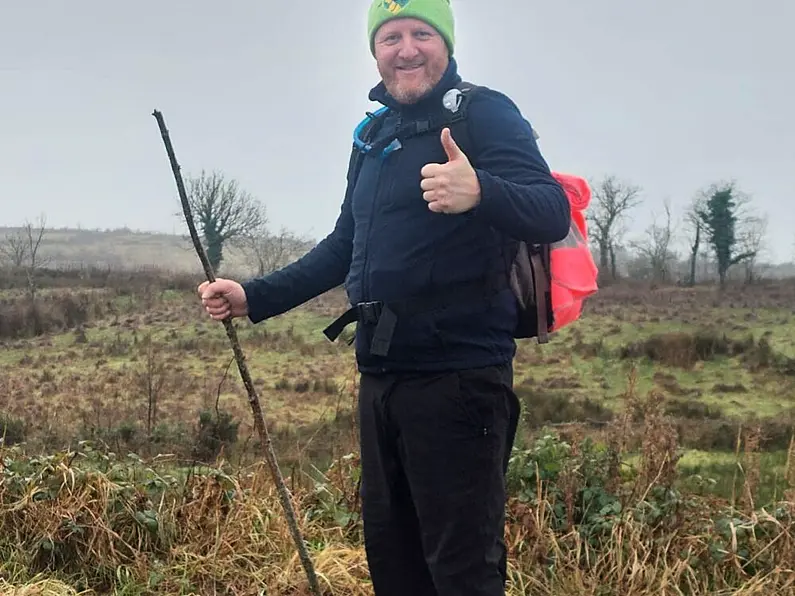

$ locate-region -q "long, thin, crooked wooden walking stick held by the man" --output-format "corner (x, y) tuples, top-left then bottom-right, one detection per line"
(152, 110), (322, 596)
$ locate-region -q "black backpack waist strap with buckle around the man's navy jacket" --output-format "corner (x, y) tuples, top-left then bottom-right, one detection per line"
(323, 275), (508, 356)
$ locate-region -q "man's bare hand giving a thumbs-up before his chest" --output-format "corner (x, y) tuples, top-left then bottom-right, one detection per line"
(420, 128), (480, 213)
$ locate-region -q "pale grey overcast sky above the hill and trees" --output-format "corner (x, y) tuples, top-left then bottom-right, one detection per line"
(0, 0), (795, 260)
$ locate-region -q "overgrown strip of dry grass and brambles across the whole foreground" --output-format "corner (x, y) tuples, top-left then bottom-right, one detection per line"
(0, 370), (795, 596)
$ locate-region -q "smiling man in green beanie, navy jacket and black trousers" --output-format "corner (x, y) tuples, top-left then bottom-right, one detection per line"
(199, 0), (570, 596)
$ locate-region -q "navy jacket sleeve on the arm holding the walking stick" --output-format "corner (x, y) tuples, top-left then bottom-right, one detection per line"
(242, 196), (353, 323)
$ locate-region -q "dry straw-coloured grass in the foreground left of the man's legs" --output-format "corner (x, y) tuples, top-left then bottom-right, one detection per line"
(0, 452), (367, 595)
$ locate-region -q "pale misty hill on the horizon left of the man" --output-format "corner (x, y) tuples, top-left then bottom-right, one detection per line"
(0, 227), (264, 272)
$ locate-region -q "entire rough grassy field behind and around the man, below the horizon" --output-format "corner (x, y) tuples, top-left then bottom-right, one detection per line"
(0, 266), (795, 595)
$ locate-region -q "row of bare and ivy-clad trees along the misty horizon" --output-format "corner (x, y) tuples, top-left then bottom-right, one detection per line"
(0, 170), (767, 290)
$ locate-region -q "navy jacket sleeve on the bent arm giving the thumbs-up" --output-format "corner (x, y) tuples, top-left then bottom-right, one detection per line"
(468, 90), (571, 244)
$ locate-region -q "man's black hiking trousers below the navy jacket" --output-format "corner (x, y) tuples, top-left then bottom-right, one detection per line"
(359, 364), (519, 596)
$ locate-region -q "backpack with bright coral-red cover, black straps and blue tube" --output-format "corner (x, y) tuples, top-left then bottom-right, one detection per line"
(324, 82), (598, 355)
